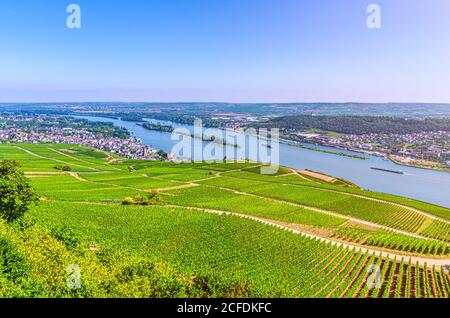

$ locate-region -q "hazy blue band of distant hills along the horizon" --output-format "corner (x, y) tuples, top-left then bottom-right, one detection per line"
(0, 102), (450, 118)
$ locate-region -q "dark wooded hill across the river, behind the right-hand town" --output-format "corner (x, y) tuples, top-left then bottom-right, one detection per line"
(258, 115), (450, 135)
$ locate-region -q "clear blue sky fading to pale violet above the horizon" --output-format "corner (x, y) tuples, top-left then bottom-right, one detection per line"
(0, 0), (450, 103)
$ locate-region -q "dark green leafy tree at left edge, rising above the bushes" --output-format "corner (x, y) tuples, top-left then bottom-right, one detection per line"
(0, 160), (39, 222)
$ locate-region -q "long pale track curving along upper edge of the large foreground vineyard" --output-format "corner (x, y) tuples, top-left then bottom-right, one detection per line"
(63, 200), (450, 267)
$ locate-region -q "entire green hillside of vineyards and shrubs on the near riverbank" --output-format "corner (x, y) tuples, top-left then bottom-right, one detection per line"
(0, 144), (450, 298)
